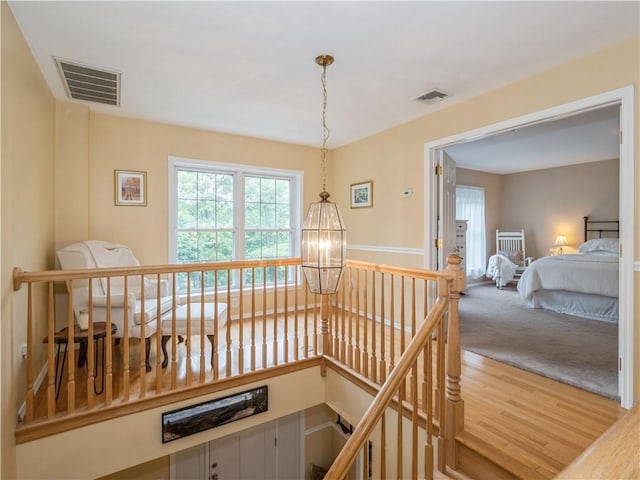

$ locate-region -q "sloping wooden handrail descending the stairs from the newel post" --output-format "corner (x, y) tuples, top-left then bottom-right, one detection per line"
(326, 276), (453, 479)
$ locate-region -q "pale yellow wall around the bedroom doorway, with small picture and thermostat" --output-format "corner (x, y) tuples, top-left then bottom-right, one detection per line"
(331, 37), (640, 399)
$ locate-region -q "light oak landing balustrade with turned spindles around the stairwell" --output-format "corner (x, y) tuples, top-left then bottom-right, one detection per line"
(14, 253), (462, 466)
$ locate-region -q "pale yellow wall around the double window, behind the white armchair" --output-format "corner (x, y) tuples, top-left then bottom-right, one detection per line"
(56, 110), (321, 264)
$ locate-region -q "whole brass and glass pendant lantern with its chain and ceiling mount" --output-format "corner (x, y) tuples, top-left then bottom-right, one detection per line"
(302, 55), (347, 294)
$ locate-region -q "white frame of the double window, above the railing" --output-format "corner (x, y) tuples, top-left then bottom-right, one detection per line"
(167, 155), (304, 263)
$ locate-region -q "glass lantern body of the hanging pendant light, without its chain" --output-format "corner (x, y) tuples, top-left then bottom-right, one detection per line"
(302, 200), (347, 294)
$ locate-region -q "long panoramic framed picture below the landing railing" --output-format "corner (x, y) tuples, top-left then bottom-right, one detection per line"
(162, 385), (269, 443)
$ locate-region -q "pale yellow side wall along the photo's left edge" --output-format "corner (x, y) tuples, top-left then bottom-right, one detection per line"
(0, 2), (55, 478)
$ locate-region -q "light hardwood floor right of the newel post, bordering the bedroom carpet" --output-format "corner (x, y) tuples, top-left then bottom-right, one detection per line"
(461, 351), (625, 479)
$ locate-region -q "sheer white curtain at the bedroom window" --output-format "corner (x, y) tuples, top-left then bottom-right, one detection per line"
(456, 185), (487, 278)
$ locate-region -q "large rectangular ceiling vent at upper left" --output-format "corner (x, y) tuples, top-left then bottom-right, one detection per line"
(53, 57), (120, 107)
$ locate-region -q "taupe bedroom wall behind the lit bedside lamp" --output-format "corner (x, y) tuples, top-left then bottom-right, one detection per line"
(502, 159), (620, 258)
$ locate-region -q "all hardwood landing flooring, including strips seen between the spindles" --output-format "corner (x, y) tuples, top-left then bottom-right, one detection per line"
(31, 314), (625, 479)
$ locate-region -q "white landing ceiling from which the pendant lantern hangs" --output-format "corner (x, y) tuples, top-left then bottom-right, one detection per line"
(9, 1), (640, 157)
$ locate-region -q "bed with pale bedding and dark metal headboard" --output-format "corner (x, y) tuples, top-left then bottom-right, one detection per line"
(518, 217), (619, 323)
